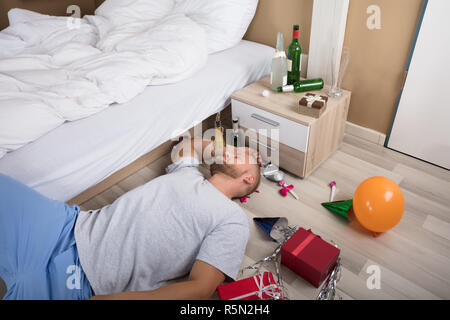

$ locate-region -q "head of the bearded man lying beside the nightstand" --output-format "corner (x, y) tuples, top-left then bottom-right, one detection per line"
(210, 148), (261, 198)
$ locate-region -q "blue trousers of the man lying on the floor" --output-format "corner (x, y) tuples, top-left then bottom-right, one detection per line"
(0, 174), (93, 300)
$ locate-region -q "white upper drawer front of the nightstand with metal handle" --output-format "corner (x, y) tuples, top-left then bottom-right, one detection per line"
(231, 99), (309, 153)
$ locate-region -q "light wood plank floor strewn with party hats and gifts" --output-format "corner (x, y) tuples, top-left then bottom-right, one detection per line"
(82, 135), (450, 299)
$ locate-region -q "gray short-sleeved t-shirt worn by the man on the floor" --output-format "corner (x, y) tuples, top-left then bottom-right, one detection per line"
(75, 158), (250, 294)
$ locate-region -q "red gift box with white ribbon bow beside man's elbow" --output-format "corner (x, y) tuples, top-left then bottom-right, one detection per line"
(217, 272), (281, 300)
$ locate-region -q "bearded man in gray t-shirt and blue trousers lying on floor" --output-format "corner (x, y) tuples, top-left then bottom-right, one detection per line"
(0, 140), (260, 299)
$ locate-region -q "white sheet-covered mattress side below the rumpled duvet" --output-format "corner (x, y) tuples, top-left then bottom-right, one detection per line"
(0, 41), (274, 201)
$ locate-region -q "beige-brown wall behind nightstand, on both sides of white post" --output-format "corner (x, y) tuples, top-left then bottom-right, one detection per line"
(246, 0), (423, 133)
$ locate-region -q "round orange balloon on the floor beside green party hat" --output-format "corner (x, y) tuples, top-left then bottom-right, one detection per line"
(353, 177), (405, 233)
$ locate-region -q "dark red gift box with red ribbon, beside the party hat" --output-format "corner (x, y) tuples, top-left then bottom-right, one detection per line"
(281, 228), (340, 288)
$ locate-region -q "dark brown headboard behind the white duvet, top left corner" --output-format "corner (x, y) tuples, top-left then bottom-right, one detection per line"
(0, 0), (95, 30)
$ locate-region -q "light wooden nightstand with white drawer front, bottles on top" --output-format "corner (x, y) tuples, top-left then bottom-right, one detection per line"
(231, 77), (351, 178)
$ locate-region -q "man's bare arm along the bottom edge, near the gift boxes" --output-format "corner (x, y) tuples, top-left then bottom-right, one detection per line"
(91, 260), (225, 300)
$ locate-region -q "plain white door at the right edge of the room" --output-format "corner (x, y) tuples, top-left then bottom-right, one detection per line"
(387, 0), (450, 169)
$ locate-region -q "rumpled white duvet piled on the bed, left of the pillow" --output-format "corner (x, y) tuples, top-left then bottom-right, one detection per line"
(0, 0), (208, 158)
